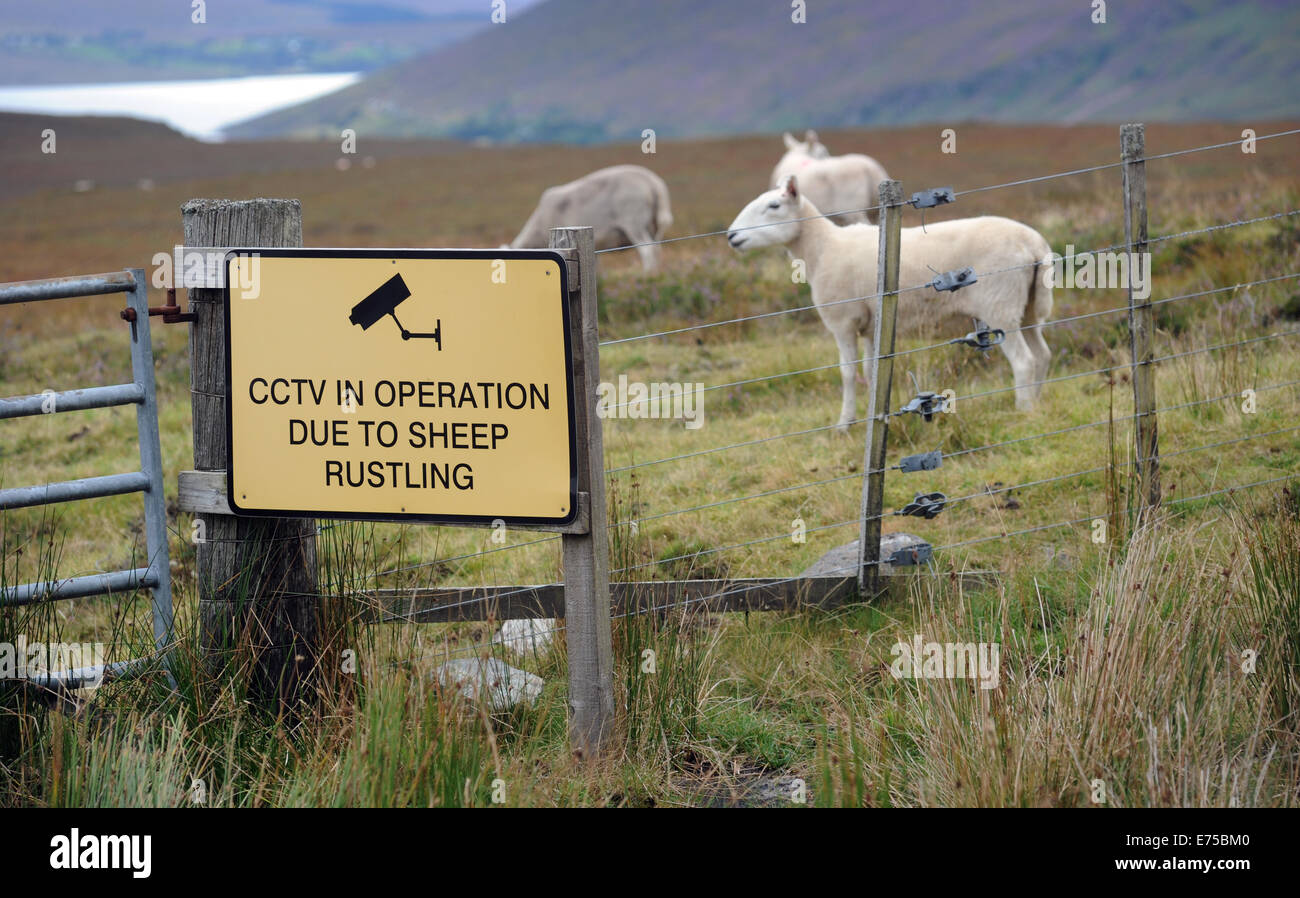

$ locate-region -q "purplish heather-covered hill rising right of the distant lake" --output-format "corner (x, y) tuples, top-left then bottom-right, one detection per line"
(231, 0), (1300, 142)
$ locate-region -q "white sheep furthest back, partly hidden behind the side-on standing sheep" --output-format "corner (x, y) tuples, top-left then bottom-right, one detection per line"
(771, 131), (889, 225)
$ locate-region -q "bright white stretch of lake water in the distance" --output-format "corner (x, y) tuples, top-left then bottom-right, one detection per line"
(0, 71), (361, 140)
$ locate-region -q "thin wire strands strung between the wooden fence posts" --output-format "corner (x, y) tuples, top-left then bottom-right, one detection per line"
(157, 129), (1300, 664)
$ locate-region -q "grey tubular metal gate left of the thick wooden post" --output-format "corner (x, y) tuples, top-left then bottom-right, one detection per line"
(0, 268), (172, 689)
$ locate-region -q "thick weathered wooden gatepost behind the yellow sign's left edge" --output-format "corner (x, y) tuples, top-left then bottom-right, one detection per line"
(181, 199), (320, 712)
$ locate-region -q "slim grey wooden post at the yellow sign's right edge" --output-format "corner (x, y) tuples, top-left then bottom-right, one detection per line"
(550, 227), (614, 760)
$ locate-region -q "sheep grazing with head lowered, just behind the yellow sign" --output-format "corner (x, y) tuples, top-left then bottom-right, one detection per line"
(510, 165), (672, 272)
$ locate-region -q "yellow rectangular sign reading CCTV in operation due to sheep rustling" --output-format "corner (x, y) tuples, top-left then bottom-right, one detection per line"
(225, 250), (576, 525)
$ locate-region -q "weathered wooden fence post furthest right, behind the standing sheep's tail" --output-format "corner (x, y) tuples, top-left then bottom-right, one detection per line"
(1119, 125), (1160, 511)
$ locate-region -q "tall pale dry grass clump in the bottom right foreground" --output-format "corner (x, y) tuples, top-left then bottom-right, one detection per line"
(819, 499), (1300, 807)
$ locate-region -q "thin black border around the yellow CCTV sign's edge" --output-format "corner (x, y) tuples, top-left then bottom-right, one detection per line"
(221, 247), (579, 529)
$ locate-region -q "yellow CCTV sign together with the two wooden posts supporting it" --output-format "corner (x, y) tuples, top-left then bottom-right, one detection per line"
(181, 200), (614, 760)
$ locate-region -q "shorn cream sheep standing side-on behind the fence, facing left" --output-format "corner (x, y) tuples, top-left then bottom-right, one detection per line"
(727, 175), (1052, 431)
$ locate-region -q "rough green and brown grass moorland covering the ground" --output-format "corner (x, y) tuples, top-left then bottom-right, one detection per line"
(0, 126), (1300, 806)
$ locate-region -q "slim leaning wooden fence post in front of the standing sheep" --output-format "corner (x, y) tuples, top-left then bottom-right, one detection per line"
(858, 181), (902, 599)
